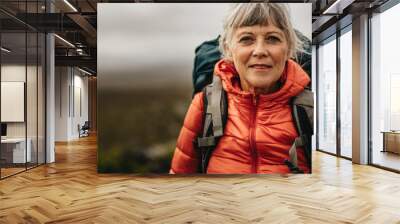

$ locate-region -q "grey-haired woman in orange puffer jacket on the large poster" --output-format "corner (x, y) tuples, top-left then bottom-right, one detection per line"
(171, 3), (310, 174)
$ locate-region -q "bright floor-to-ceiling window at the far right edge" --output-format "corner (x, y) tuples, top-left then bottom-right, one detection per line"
(370, 1), (400, 170)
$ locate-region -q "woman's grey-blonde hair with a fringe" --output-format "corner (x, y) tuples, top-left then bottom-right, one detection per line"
(219, 2), (304, 58)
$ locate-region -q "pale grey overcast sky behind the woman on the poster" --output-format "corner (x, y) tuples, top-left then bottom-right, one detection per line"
(97, 3), (311, 88)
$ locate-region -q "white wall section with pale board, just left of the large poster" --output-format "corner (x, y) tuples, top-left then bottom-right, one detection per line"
(55, 67), (89, 141)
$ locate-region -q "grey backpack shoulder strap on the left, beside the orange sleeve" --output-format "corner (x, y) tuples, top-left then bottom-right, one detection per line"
(196, 75), (228, 173)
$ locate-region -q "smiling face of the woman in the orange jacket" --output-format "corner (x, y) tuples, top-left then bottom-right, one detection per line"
(227, 25), (289, 93)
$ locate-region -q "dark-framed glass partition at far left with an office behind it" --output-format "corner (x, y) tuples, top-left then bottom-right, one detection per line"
(0, 1), (46, 178)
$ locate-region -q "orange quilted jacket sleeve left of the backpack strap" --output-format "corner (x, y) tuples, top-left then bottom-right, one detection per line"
(170, 92), (204, 174)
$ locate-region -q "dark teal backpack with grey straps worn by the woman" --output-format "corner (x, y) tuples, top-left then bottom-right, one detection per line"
(193, 32), (314, 173)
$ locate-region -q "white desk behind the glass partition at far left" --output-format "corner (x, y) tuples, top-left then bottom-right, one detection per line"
(1, 138), (32, 163)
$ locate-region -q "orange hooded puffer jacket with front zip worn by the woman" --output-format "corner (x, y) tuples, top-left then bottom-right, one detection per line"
(170, 59), (310, 174)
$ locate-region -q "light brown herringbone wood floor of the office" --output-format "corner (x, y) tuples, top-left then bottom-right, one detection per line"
(0, 137), (400, 224)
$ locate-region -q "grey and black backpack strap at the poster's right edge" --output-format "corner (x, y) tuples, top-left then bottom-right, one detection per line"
(285, 88), (314, 173)
